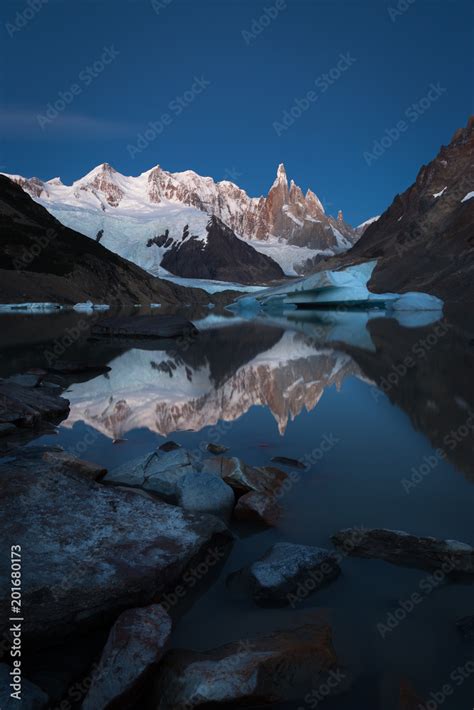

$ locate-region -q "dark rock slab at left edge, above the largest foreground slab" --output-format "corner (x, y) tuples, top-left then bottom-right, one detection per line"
(0, 380), (69, 428)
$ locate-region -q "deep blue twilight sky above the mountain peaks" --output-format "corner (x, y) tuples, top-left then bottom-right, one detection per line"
(0, 0), (474, 224)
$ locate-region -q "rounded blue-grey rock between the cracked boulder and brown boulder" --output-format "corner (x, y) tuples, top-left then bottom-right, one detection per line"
(177, 471), (235, 521)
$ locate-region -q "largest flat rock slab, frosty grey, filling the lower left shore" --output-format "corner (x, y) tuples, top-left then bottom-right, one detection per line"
(0, 459), (231, 644)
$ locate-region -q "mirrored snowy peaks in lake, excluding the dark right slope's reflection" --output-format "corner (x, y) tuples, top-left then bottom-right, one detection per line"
(65, 324), (359, 439)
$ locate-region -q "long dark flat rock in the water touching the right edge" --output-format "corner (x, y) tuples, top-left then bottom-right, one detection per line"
(332, 528), (474, 576)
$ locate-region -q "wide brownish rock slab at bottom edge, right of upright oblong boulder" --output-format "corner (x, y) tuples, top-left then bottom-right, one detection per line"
(153, 624), (337, 710)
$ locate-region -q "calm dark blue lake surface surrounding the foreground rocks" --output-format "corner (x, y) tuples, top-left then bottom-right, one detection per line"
(0, 312), (474, 710)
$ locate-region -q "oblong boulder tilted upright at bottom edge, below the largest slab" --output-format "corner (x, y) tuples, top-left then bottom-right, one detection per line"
(82, 604), (171, 710)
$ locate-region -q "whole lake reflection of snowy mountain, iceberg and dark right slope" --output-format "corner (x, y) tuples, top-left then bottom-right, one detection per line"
(52, 312), (474, 484)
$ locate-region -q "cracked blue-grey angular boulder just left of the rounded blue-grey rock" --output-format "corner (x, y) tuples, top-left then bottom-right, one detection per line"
(104, 447), (195, 503)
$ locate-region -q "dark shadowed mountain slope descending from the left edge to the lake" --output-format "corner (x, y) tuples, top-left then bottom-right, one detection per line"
(0, 175), (209, 304)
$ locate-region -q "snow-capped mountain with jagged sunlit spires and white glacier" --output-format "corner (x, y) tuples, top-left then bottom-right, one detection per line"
(3, 163), (359, 275)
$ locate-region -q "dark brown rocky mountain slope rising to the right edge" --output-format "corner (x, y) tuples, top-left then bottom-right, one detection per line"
(304, 117), (474, 302)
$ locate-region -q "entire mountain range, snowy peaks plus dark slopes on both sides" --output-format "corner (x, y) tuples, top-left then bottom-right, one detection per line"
(0, 117), (474, 302)
